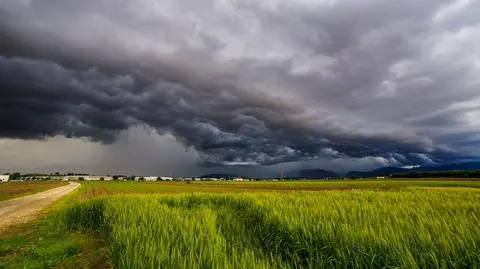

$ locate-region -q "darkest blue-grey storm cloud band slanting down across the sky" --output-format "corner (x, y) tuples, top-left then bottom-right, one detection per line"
(0, 55), (454, 164)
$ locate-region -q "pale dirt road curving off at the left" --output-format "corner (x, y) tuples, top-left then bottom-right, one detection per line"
(0, 182), (80, 232)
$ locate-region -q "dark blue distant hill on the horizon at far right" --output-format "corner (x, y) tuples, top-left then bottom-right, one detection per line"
(347, 162), (480, 177)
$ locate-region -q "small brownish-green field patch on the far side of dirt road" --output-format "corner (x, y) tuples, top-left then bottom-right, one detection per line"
(0, 180), (68, 201)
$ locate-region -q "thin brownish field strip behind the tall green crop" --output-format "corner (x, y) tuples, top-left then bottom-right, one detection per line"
(75, 179), (480, 199)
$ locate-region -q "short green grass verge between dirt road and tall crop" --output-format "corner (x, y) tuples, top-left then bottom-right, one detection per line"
(0, 184), (111, 269)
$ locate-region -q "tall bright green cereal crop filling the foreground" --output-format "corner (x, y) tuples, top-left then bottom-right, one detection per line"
(60, 188), (480, 268)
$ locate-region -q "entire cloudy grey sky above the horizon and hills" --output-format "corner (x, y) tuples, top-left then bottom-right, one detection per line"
(0, 0), (480, 176)
